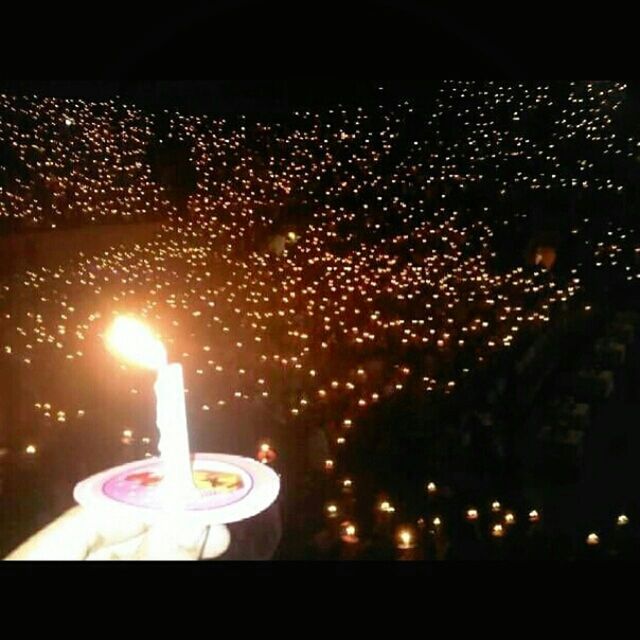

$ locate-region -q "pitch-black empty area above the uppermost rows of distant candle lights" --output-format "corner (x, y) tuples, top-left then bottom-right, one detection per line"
(0, 0), (640, 119)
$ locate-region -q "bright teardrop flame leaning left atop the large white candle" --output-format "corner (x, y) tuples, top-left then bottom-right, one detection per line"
(106, 316), (167, 369)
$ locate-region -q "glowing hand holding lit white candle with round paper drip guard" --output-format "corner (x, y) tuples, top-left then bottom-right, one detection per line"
(15, 316), (280, 560)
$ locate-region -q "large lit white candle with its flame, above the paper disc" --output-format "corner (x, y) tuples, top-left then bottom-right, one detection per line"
(107, 316), (196, 507)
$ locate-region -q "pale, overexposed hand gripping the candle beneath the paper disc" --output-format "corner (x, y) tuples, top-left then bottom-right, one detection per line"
(5, 506), (230, 560)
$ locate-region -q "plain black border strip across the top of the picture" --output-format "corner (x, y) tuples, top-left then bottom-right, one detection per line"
(0, 0), (635, 78)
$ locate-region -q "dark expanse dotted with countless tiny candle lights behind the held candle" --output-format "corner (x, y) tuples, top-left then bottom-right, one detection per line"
(0, 81), (640, 560)
